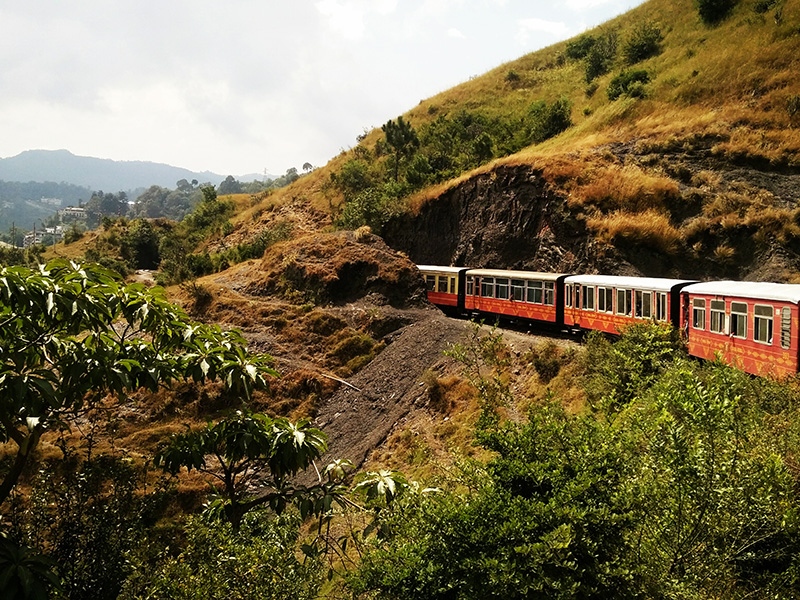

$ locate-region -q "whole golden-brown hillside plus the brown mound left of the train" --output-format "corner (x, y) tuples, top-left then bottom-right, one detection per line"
(43, 0), (800, 464)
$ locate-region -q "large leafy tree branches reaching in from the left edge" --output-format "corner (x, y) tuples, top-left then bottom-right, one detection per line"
(0, 260), (276, 504)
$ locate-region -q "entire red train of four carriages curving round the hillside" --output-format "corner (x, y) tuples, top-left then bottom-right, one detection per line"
(419, 265), (800, 377)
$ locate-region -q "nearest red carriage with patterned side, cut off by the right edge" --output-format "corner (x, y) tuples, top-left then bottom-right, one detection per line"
(681, 281), (800, 377)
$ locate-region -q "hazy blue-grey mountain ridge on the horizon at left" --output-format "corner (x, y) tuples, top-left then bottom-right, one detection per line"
(0, 150), (263, 193)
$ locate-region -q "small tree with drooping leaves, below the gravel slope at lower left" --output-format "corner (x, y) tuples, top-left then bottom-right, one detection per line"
(155, 411), (344, 531)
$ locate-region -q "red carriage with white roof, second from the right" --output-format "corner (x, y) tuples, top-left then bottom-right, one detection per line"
(564, 275), (693, 334)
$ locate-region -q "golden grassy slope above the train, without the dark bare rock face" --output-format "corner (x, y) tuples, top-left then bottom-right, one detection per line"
(208, 0), (800, 280)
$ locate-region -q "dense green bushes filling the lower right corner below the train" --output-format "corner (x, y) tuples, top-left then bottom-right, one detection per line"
(348, 324), (800, 600)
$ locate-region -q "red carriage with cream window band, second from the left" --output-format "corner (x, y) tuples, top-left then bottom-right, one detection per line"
(464, 269), (567, 325)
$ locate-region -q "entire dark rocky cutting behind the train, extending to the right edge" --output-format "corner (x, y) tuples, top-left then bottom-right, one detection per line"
(383, 146), (800, 281)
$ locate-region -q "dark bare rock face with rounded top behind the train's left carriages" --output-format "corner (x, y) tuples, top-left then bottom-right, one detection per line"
(384, 167), (590, 271)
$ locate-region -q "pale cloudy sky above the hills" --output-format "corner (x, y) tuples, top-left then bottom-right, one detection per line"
(0, 0), (642, 176)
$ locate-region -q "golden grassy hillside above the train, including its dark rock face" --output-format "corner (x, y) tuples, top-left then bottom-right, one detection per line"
(209, 0), (800, 281)
